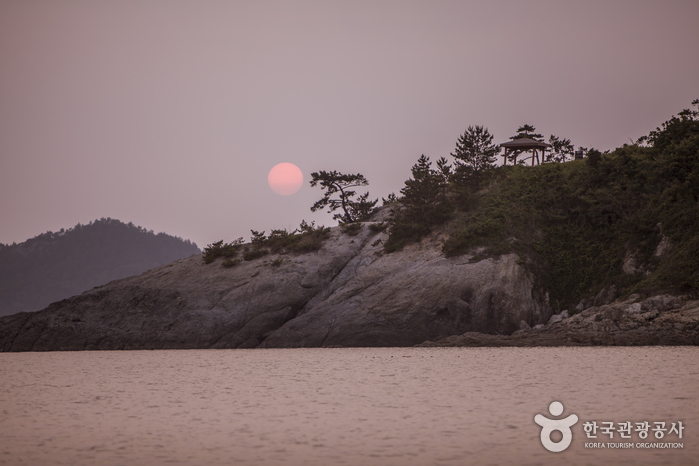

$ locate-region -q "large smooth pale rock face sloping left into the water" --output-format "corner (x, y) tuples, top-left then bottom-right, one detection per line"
(0, 227), (551, 351)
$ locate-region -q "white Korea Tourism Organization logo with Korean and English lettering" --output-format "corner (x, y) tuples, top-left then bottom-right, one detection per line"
(534, 401), (684, 453)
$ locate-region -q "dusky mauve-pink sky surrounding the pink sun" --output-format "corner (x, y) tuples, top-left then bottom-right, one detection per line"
(0, 0), (699, 248)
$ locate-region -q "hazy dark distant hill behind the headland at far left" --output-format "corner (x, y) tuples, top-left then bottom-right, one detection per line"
(0, 218), (201, 316)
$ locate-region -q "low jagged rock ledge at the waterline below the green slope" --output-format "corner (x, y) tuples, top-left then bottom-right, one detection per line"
(421, 296), (699, 346)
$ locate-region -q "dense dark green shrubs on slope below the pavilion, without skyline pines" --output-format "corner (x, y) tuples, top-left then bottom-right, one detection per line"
(443, 101), (699, 307)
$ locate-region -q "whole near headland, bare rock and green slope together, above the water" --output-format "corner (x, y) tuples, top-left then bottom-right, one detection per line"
(0, 101), (699, 351)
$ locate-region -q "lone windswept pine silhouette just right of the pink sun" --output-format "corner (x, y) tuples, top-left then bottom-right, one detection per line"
(311, 171), (378, 223)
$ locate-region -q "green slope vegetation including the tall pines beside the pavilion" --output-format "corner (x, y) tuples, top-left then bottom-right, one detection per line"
(384, 101), (699, 308)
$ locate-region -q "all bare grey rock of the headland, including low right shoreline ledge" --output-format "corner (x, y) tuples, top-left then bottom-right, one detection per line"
(0, 209), (699, 351)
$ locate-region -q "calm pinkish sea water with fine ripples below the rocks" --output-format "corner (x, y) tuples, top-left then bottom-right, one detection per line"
(0, 347), (699, 465)
